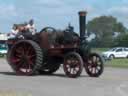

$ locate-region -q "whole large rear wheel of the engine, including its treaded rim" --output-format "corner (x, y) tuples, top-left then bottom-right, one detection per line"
(8, 40), (43, 75)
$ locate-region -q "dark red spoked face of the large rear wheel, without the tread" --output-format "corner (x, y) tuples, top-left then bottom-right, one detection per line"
(10, 42), (36, 75)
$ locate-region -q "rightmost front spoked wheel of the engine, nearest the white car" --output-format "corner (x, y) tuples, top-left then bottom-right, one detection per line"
(85, 53), (104, 77)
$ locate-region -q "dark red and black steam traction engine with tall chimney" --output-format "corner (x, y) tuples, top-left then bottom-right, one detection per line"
(7, 11), (103, 78)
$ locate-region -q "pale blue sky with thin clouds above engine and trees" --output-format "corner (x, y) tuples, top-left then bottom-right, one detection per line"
(0, 0), (128, 33)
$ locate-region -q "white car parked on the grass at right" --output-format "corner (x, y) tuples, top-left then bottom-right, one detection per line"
(102, 47), (128, 59)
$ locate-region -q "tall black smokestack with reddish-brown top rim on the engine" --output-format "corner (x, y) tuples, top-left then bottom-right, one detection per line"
(79, 11), (87, 40)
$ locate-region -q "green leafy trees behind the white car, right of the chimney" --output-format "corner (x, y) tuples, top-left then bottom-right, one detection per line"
(87, 16), (128, 47)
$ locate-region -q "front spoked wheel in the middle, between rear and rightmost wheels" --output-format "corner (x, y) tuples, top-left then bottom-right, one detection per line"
(63, 52), (83, 78)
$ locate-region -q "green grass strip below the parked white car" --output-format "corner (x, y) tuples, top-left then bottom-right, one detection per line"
(105, 59), (128, 68)
